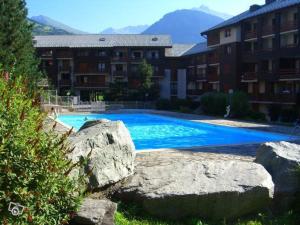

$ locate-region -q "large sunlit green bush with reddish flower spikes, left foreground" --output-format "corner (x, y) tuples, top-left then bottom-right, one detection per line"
(0, 72), (81, 225)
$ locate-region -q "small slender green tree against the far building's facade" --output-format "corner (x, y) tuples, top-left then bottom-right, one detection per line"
(138, 60), (153, 98)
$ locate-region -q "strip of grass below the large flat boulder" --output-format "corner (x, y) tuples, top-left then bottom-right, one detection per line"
(115, 203), (300, 225)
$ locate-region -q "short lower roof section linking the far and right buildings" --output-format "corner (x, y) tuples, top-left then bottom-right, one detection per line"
(166, 42), (212, 57)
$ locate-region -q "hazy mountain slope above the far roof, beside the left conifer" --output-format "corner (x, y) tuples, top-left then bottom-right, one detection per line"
(30, 15), (86, 34)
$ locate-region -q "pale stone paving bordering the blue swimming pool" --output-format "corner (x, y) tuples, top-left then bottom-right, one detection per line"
(49, 110), (300, 157)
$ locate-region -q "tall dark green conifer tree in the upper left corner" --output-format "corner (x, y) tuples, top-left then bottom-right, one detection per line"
(0, 0), (41, 86)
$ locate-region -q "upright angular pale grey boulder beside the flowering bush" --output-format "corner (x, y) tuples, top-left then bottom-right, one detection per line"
(69, 121), (135, 189)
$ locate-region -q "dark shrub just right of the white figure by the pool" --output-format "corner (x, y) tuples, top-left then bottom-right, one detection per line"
(230, 91), (250, 118)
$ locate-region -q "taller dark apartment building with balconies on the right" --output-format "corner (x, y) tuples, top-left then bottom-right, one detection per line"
(202, 0), (300, 113)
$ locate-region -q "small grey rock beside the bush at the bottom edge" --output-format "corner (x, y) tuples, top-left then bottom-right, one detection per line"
(71, 198), (117, 225)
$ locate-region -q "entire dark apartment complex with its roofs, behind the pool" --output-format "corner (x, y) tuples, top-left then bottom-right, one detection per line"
(35, 0), (300, 113)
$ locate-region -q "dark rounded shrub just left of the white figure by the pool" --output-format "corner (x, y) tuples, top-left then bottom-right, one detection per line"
(201, 92), (228, 116)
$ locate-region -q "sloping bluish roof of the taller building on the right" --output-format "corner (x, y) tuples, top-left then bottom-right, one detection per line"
(201, 0), (300, 34)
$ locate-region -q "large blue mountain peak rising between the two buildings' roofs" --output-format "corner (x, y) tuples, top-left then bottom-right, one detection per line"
(143, 9), (224, 43)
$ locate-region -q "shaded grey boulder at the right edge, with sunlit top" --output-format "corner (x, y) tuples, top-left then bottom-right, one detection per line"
(255, 142), (300, 209)
